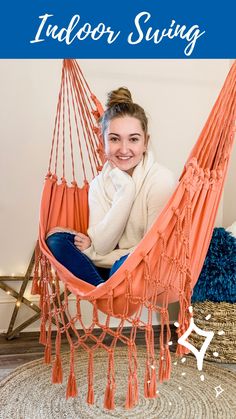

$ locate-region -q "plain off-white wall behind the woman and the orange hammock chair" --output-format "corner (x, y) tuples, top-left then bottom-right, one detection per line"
(0, 60), (233, 331)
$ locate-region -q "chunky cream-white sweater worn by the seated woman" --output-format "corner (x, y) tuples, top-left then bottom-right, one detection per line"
(83, 151), (176, 268)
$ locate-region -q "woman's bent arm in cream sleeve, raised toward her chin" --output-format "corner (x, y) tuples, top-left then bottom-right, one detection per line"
(88, 168), (135, 256)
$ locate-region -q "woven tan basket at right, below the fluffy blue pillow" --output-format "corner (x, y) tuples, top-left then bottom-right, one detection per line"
(189, 301), (236, 364)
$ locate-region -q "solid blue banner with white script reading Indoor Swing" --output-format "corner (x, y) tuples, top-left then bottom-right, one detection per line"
(0, 0), (236, 58)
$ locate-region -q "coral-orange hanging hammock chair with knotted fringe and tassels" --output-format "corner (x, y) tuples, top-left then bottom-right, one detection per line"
(32, 59), (236, 409)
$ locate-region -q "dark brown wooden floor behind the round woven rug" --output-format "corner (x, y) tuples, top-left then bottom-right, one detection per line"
(0, 327), (236, 380)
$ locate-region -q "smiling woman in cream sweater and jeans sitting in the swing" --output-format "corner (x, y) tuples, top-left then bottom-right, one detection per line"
(46, 87), (175, 285)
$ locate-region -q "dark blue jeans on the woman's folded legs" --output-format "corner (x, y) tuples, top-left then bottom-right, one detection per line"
(46, 232), (128, 286)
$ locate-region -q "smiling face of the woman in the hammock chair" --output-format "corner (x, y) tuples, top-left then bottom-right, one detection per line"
(104, 116), (147, 176)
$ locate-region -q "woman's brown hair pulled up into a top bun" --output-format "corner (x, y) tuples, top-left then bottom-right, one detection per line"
(99, 87), (148, 136)
